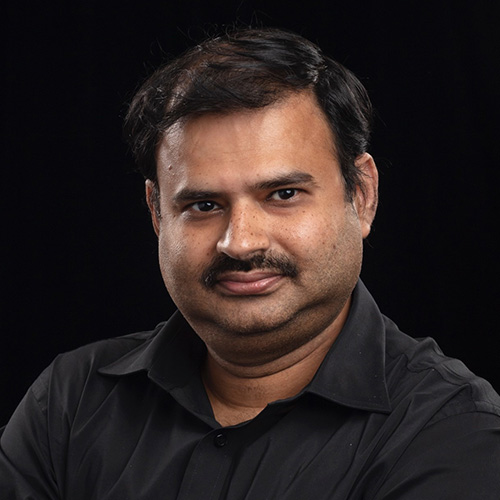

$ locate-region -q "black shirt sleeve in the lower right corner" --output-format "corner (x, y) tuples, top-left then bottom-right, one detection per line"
(373, 413), (500, 500)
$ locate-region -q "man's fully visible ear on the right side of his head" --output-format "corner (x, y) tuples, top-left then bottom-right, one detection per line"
(354, 153), (378, 238)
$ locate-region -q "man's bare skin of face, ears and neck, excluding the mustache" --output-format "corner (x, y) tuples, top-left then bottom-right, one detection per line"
(146, 92), (378, 425)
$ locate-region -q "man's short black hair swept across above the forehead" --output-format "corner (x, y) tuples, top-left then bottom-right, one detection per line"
(124, 28), (372, 200)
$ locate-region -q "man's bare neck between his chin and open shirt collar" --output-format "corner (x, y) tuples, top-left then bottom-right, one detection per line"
(203, 308), (343, 426)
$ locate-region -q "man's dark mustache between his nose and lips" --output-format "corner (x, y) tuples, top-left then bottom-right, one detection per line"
(201, 254), (299, 288)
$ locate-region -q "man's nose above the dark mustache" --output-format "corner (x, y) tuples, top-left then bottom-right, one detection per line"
(217, 205), (270, 260)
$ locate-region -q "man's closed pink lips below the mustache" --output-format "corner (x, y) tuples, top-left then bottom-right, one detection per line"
(217, 271), (283, 295)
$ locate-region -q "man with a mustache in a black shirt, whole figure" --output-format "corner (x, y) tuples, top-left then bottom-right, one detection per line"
(0, 30), (500, 500)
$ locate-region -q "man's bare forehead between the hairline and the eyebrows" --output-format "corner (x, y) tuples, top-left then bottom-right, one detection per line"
(157, 92), (338, 186)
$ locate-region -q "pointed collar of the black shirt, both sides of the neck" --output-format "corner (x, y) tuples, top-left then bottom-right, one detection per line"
(99, 281), (391, 413)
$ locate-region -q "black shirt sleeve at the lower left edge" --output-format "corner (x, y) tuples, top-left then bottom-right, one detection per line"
(0, 372), (60, 500)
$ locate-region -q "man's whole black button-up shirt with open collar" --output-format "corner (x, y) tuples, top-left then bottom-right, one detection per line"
(0, 283), (500, 500)
